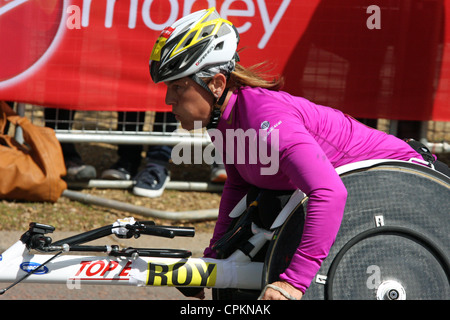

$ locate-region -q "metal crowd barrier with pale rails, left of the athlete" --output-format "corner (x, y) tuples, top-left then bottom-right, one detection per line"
(15, 103), (223, 192)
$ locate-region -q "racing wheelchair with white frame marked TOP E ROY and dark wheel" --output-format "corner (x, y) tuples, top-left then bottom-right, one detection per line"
(0, 160), (450, 300)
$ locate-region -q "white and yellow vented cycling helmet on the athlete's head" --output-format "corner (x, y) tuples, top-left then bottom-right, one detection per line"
(150, 8), (239, 83)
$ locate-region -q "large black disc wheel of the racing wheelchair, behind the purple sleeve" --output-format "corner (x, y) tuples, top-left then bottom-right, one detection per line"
(263, 162), (450, 300)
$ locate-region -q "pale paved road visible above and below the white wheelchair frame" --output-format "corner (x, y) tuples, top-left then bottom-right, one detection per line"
(0, 231), (211, 300)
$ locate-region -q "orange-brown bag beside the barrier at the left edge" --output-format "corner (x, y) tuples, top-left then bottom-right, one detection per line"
(0, 101), (67, 202)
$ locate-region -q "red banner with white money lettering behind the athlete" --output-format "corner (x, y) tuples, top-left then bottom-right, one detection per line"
(0, 0), (450, 121)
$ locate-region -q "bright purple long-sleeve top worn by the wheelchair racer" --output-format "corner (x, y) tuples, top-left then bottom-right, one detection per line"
(204, 87), (422, 292)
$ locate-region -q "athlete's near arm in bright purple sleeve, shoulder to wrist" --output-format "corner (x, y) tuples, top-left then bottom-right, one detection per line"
(280, 125), (347, 293)
